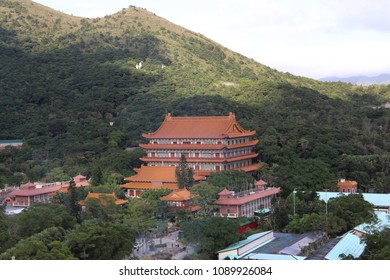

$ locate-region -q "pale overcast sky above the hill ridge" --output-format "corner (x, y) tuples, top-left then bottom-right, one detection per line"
(35, 0), (390, 78)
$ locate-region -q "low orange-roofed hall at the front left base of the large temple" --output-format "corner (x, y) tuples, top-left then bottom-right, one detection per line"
(121, 165), (204, 197)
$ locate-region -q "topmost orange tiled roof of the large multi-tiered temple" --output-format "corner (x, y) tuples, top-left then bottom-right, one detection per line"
(143, 113), (256, 139)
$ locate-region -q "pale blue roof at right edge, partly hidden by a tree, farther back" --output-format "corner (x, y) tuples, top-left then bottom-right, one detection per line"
(317, 192), (390, 214)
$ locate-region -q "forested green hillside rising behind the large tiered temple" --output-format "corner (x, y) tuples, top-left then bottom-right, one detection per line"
(0, 0), (390, 191)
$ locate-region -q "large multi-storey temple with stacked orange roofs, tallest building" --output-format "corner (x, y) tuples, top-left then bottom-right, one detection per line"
(140, 113), (259, 176)
